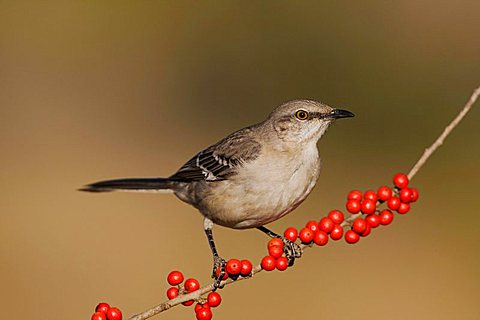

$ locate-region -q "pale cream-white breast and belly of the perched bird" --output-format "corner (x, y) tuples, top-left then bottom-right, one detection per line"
(199, 145), (320, 229)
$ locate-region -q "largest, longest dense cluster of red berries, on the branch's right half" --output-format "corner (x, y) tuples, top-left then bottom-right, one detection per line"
(261, 173), (418, 271)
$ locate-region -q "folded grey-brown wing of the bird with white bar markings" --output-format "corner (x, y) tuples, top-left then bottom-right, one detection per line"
(169, 128), (261, 182)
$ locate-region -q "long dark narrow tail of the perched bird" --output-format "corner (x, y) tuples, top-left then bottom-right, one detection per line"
(79, 178), (173, 192)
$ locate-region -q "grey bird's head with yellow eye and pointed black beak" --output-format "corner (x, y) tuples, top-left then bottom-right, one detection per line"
(266, 100), (354, 143)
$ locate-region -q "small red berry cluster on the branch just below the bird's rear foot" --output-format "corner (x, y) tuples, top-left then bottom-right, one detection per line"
(167, 270), (225, 320)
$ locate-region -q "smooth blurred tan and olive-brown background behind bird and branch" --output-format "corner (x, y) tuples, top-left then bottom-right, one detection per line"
(0, 1), (480, 320)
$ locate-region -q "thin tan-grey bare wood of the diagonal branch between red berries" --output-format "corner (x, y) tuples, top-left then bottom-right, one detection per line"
(129, 87), (480, 320)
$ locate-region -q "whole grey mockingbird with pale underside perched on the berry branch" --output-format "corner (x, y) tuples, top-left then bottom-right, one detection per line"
(81, 100), (354, 286)
